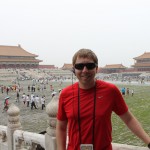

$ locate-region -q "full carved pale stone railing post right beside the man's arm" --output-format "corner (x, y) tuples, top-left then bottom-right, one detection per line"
(45, 95), (59, 150)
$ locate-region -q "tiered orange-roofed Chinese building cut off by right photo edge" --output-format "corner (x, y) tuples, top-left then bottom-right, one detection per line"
(132, 52), (150, 71)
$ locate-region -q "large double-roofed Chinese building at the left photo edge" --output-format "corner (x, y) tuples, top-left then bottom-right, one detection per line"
(0, 45), (42, 69)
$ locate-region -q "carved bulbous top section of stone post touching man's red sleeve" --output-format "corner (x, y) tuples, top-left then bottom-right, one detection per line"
(46, 95), (59, 137)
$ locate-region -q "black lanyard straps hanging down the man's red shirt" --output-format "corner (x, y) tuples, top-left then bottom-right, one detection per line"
(78, 84), (96, 149)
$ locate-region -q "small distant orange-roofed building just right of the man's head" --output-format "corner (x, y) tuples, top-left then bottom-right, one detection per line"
(100, 64), (126, 73)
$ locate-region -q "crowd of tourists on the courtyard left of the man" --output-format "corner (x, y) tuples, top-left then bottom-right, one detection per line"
(0, 76), (63, 112)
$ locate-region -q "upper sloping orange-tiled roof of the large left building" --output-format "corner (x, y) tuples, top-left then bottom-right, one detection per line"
(0, 45), (38, 57)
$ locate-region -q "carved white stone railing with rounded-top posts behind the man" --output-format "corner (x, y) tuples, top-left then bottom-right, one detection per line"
(0, 95), (148, 150)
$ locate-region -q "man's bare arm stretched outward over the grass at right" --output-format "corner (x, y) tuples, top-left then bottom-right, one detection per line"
(120, 111), (150, 144)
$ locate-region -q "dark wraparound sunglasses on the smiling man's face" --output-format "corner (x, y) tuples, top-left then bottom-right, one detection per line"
(74, 63), (97, 70)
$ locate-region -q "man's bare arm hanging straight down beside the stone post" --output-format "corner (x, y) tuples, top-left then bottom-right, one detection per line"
(56, 120), (67, 150)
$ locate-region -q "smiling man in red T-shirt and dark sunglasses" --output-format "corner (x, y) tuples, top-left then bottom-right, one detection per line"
(56, 49), (150, 150)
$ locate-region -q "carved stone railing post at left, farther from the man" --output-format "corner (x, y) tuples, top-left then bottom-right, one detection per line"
(7, 104), (21, 150)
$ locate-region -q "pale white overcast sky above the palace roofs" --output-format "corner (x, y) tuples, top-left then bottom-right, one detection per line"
(0, 0), (150, 67)
